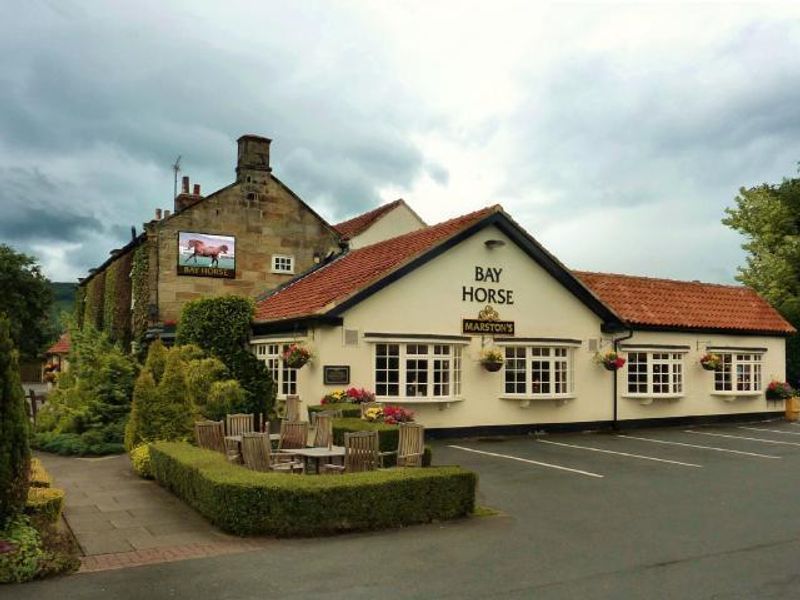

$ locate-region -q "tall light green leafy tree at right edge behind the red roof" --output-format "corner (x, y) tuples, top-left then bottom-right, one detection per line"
(722, 173), (800, 385)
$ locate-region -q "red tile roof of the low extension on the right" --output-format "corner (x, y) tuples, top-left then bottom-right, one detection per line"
(573, 271), (795, 333)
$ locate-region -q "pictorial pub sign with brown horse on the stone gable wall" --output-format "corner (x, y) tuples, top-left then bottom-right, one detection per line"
(178, 231), (236, 279)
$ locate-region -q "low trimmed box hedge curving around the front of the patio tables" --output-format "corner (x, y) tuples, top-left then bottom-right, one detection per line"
(150, 442), (477, 536)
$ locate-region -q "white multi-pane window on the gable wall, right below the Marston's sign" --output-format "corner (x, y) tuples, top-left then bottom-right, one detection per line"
(504, 346), (572, 396)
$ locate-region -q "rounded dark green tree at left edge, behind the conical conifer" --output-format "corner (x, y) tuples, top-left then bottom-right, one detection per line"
(0, 244), (53, 358)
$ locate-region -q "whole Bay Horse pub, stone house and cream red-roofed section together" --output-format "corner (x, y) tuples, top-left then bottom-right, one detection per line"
(76, 134), (795, 431)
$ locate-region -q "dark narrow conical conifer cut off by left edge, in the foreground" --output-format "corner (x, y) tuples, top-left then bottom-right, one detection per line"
(0, 315), (31, 529)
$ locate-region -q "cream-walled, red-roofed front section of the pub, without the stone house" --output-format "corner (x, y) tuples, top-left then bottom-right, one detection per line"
(251, 206), (795, 431)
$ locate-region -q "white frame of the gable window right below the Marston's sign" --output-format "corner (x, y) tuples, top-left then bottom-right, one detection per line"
(502, 344), (575, 398)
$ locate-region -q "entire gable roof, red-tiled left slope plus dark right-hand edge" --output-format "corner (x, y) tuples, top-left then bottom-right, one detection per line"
(255, 205), (621, 324)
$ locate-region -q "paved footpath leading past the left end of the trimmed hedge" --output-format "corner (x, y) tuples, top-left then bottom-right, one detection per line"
(37, 453), (275, 572)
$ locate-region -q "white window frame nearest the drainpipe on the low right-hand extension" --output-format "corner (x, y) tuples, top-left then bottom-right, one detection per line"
(623, 349), (686, 398)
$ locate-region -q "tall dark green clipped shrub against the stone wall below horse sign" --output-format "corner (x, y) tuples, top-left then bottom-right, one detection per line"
(175, 296), (275, 414)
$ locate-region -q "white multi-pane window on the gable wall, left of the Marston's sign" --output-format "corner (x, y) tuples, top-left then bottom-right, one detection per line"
(375, 344), (461, 398)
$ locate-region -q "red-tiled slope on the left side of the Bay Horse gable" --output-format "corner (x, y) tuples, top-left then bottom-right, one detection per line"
(255, 205), (503, 321)
